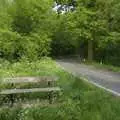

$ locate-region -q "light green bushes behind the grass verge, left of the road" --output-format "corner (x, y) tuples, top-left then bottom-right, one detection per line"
(0, 30), (51, 60)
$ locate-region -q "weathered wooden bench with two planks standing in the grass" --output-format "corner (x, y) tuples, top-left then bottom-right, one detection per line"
(0, 76), (61, 105)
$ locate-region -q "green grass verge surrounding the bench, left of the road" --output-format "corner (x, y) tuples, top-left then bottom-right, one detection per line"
(0, 58), (120, 120)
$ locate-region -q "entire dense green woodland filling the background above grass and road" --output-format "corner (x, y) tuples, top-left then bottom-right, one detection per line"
(0, 0), (120, 66)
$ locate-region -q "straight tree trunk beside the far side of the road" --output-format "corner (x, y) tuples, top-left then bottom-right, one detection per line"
(88, 40), (93, 62)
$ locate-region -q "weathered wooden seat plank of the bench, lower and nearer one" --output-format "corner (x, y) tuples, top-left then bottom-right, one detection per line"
(0, 87), (61, 95)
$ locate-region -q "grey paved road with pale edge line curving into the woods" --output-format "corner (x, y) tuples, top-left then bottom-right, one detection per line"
(56, 59), (120, 96)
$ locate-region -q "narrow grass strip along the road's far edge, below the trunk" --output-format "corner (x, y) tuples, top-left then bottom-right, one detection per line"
(84, 61), (120, 72)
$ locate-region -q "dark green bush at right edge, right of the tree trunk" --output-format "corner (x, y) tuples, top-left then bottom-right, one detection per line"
(96, 32), (120, 66)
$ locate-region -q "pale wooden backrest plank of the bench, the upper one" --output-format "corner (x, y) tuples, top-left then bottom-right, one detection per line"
(4, 76), (58, 84)
